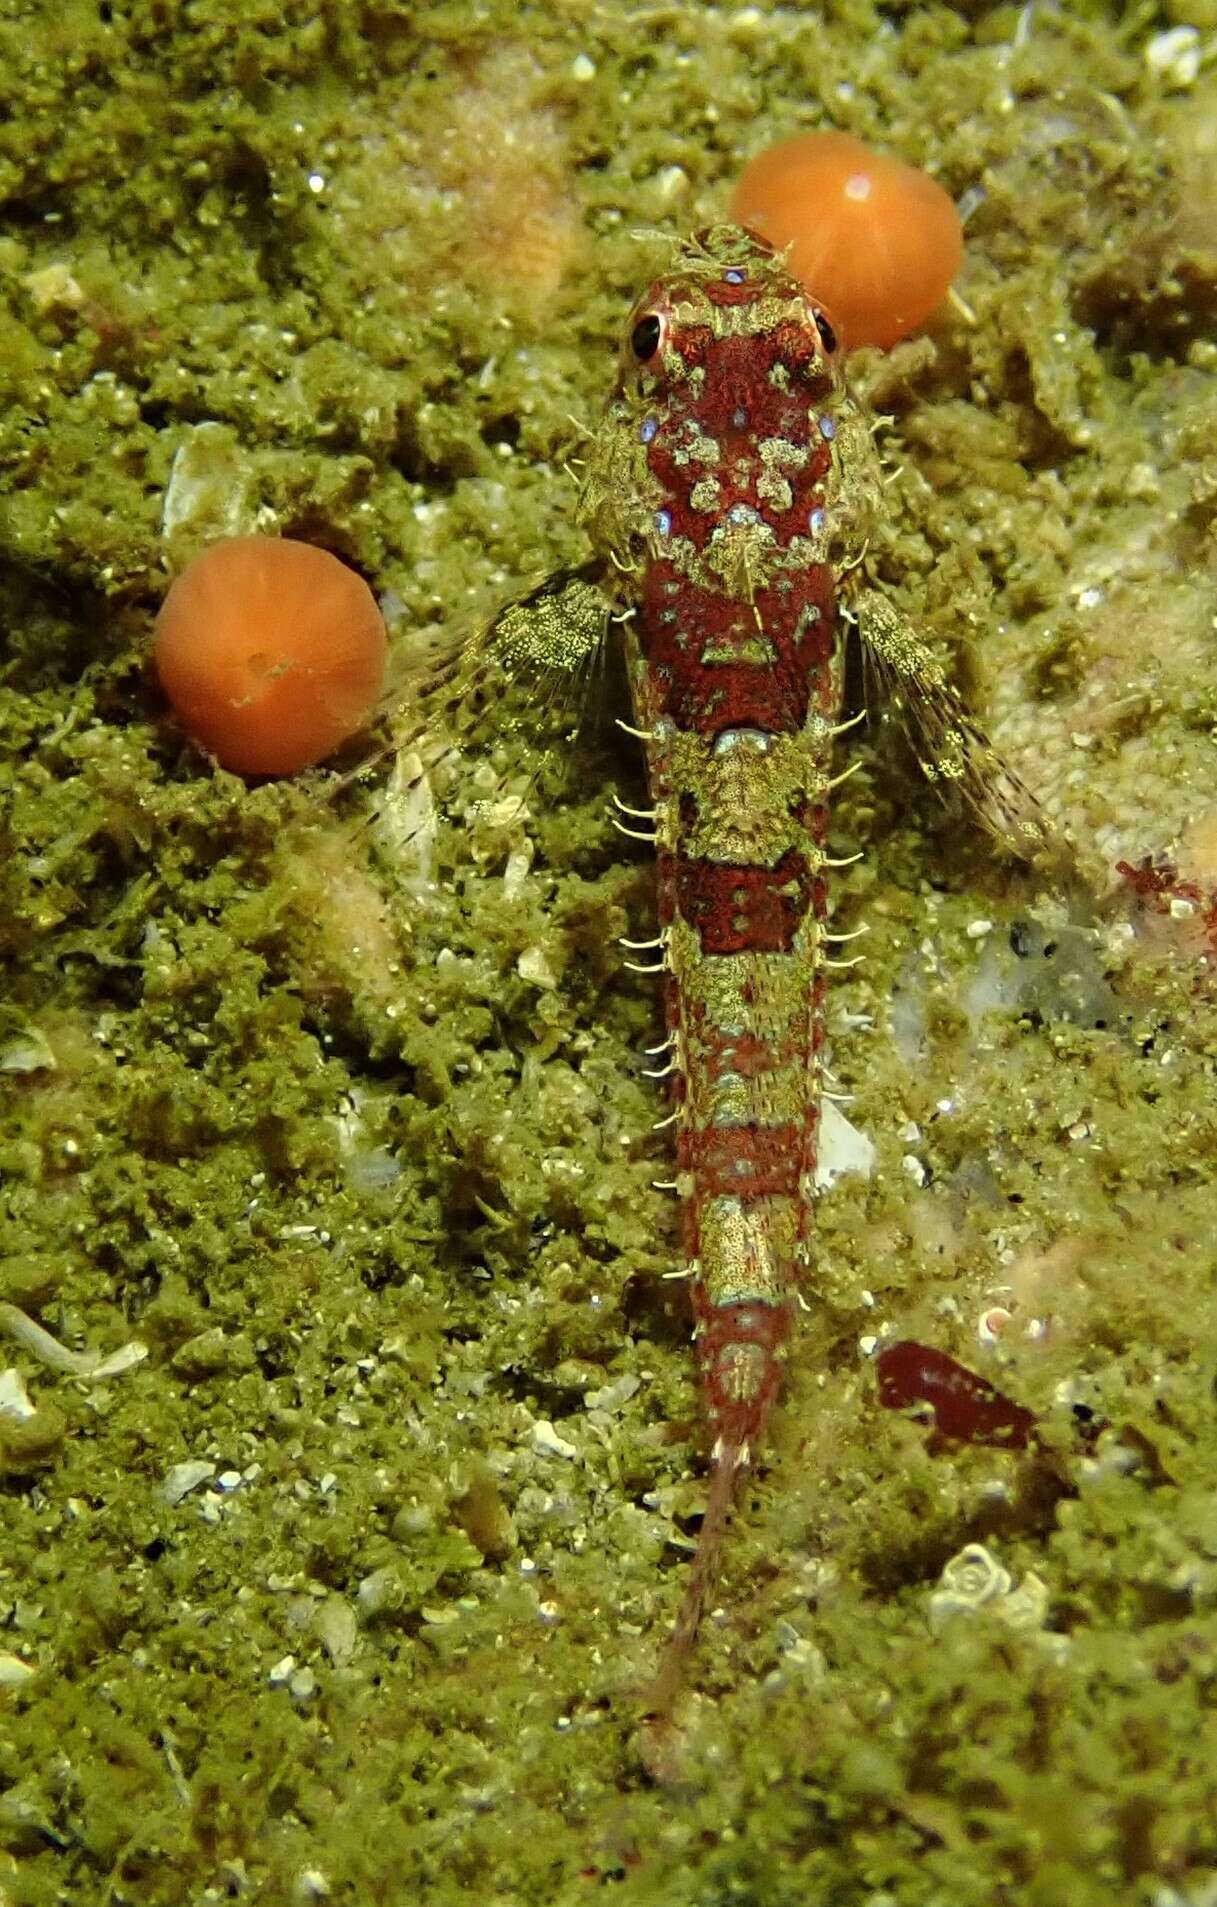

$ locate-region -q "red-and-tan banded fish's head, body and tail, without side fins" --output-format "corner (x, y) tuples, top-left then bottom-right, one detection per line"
(580, 227), (874, 1716)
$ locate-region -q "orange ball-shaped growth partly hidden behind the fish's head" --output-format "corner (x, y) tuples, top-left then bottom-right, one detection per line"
(731, 132), (963, 345)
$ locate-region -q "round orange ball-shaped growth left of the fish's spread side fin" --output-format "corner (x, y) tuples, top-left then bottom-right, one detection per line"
(153, 536), (387, 774)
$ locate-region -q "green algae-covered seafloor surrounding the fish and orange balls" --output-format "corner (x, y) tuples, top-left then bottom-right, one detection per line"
(0, 0), (1217, 1907)
